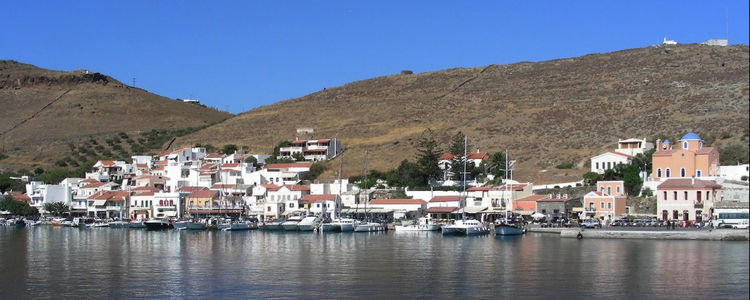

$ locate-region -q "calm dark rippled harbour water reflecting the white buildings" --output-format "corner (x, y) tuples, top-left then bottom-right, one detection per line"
(0, 226), (749, 299)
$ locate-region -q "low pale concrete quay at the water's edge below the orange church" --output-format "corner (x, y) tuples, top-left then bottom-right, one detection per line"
(527, 227), (750, 241)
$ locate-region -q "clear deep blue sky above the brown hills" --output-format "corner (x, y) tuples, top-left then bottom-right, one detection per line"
(0, 0), (750, 113)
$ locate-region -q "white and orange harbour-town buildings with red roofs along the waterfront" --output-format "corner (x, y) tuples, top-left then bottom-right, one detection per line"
(7, 133), (748, 221)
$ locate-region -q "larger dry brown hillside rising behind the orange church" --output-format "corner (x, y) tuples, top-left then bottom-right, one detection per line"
(174, 45), (749, 182)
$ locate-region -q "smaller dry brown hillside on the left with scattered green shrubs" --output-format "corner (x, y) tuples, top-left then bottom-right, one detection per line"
(0, 60), (231, 169)
